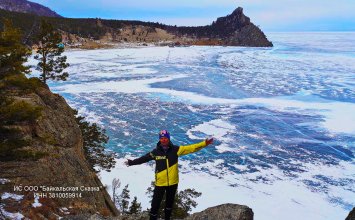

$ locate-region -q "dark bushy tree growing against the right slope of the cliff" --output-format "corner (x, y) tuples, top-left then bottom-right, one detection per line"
(73, 109), (116, 171)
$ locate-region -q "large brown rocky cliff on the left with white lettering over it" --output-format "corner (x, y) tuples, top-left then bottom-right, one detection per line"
(0, 76), (119, 219)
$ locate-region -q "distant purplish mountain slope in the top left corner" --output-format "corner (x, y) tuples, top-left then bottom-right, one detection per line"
(0, 0), (62, 17)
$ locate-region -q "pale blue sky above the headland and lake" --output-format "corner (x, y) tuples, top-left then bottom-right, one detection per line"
(31, 0), (355, 32)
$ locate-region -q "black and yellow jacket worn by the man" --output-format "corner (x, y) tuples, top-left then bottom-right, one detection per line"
(128, 141), (206, 186)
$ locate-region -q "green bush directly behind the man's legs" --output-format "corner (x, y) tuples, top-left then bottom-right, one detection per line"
(146, 182), (202, 219)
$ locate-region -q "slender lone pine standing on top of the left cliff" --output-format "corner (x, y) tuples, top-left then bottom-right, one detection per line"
(34, 20), (69, 83)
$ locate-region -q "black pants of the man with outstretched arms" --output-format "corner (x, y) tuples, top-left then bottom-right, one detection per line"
(150, 184), (178, 220)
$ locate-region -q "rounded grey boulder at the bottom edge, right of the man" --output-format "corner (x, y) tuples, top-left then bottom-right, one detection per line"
(186, 203), (254, 220)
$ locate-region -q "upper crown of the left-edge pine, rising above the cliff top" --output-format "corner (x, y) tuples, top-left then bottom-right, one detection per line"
(0, 19), (31, 79)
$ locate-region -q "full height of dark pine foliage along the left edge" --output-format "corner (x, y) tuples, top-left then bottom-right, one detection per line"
(0, 19), (44, 161)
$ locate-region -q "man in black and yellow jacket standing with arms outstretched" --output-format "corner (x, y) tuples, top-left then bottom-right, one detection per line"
(125, 130), (213, 220)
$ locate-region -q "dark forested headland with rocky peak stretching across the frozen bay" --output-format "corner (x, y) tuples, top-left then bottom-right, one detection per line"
(0, 0), (273, 49)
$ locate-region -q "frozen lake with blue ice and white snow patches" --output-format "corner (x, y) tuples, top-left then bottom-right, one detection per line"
(31, 33), (355, 220)
